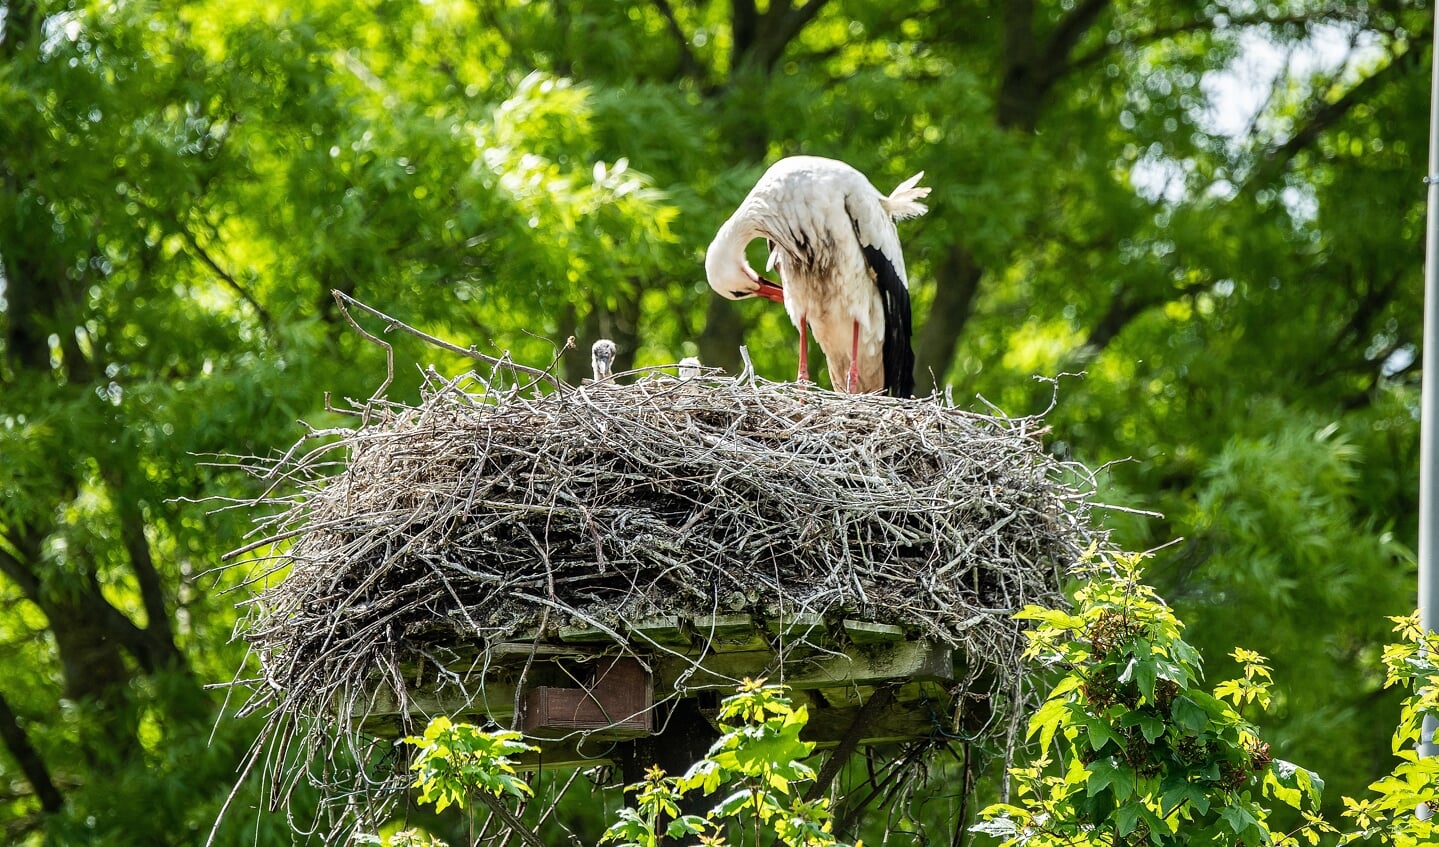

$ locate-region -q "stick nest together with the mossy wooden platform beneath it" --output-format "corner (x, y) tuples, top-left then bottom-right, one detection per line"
(230, 366), (1094, 822)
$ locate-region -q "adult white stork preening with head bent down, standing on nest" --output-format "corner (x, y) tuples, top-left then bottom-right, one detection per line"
(705, 155), (930, 397)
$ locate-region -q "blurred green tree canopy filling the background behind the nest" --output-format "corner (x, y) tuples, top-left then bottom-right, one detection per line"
(0, 0), (1433, 844)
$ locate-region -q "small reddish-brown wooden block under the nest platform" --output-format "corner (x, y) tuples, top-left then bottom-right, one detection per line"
(521, 657), (655, 739)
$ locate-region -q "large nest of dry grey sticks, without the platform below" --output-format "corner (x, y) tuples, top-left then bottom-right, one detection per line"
(221, 366), (1094, 834)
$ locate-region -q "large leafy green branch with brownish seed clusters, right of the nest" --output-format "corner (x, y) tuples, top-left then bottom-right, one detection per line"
(974, 555), (1324, 847)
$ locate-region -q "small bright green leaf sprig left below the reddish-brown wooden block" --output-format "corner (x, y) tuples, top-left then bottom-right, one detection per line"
(404, 715), (538, 811)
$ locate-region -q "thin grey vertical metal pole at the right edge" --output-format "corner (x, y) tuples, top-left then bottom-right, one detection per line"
(1419, 6), (1439, 756)
